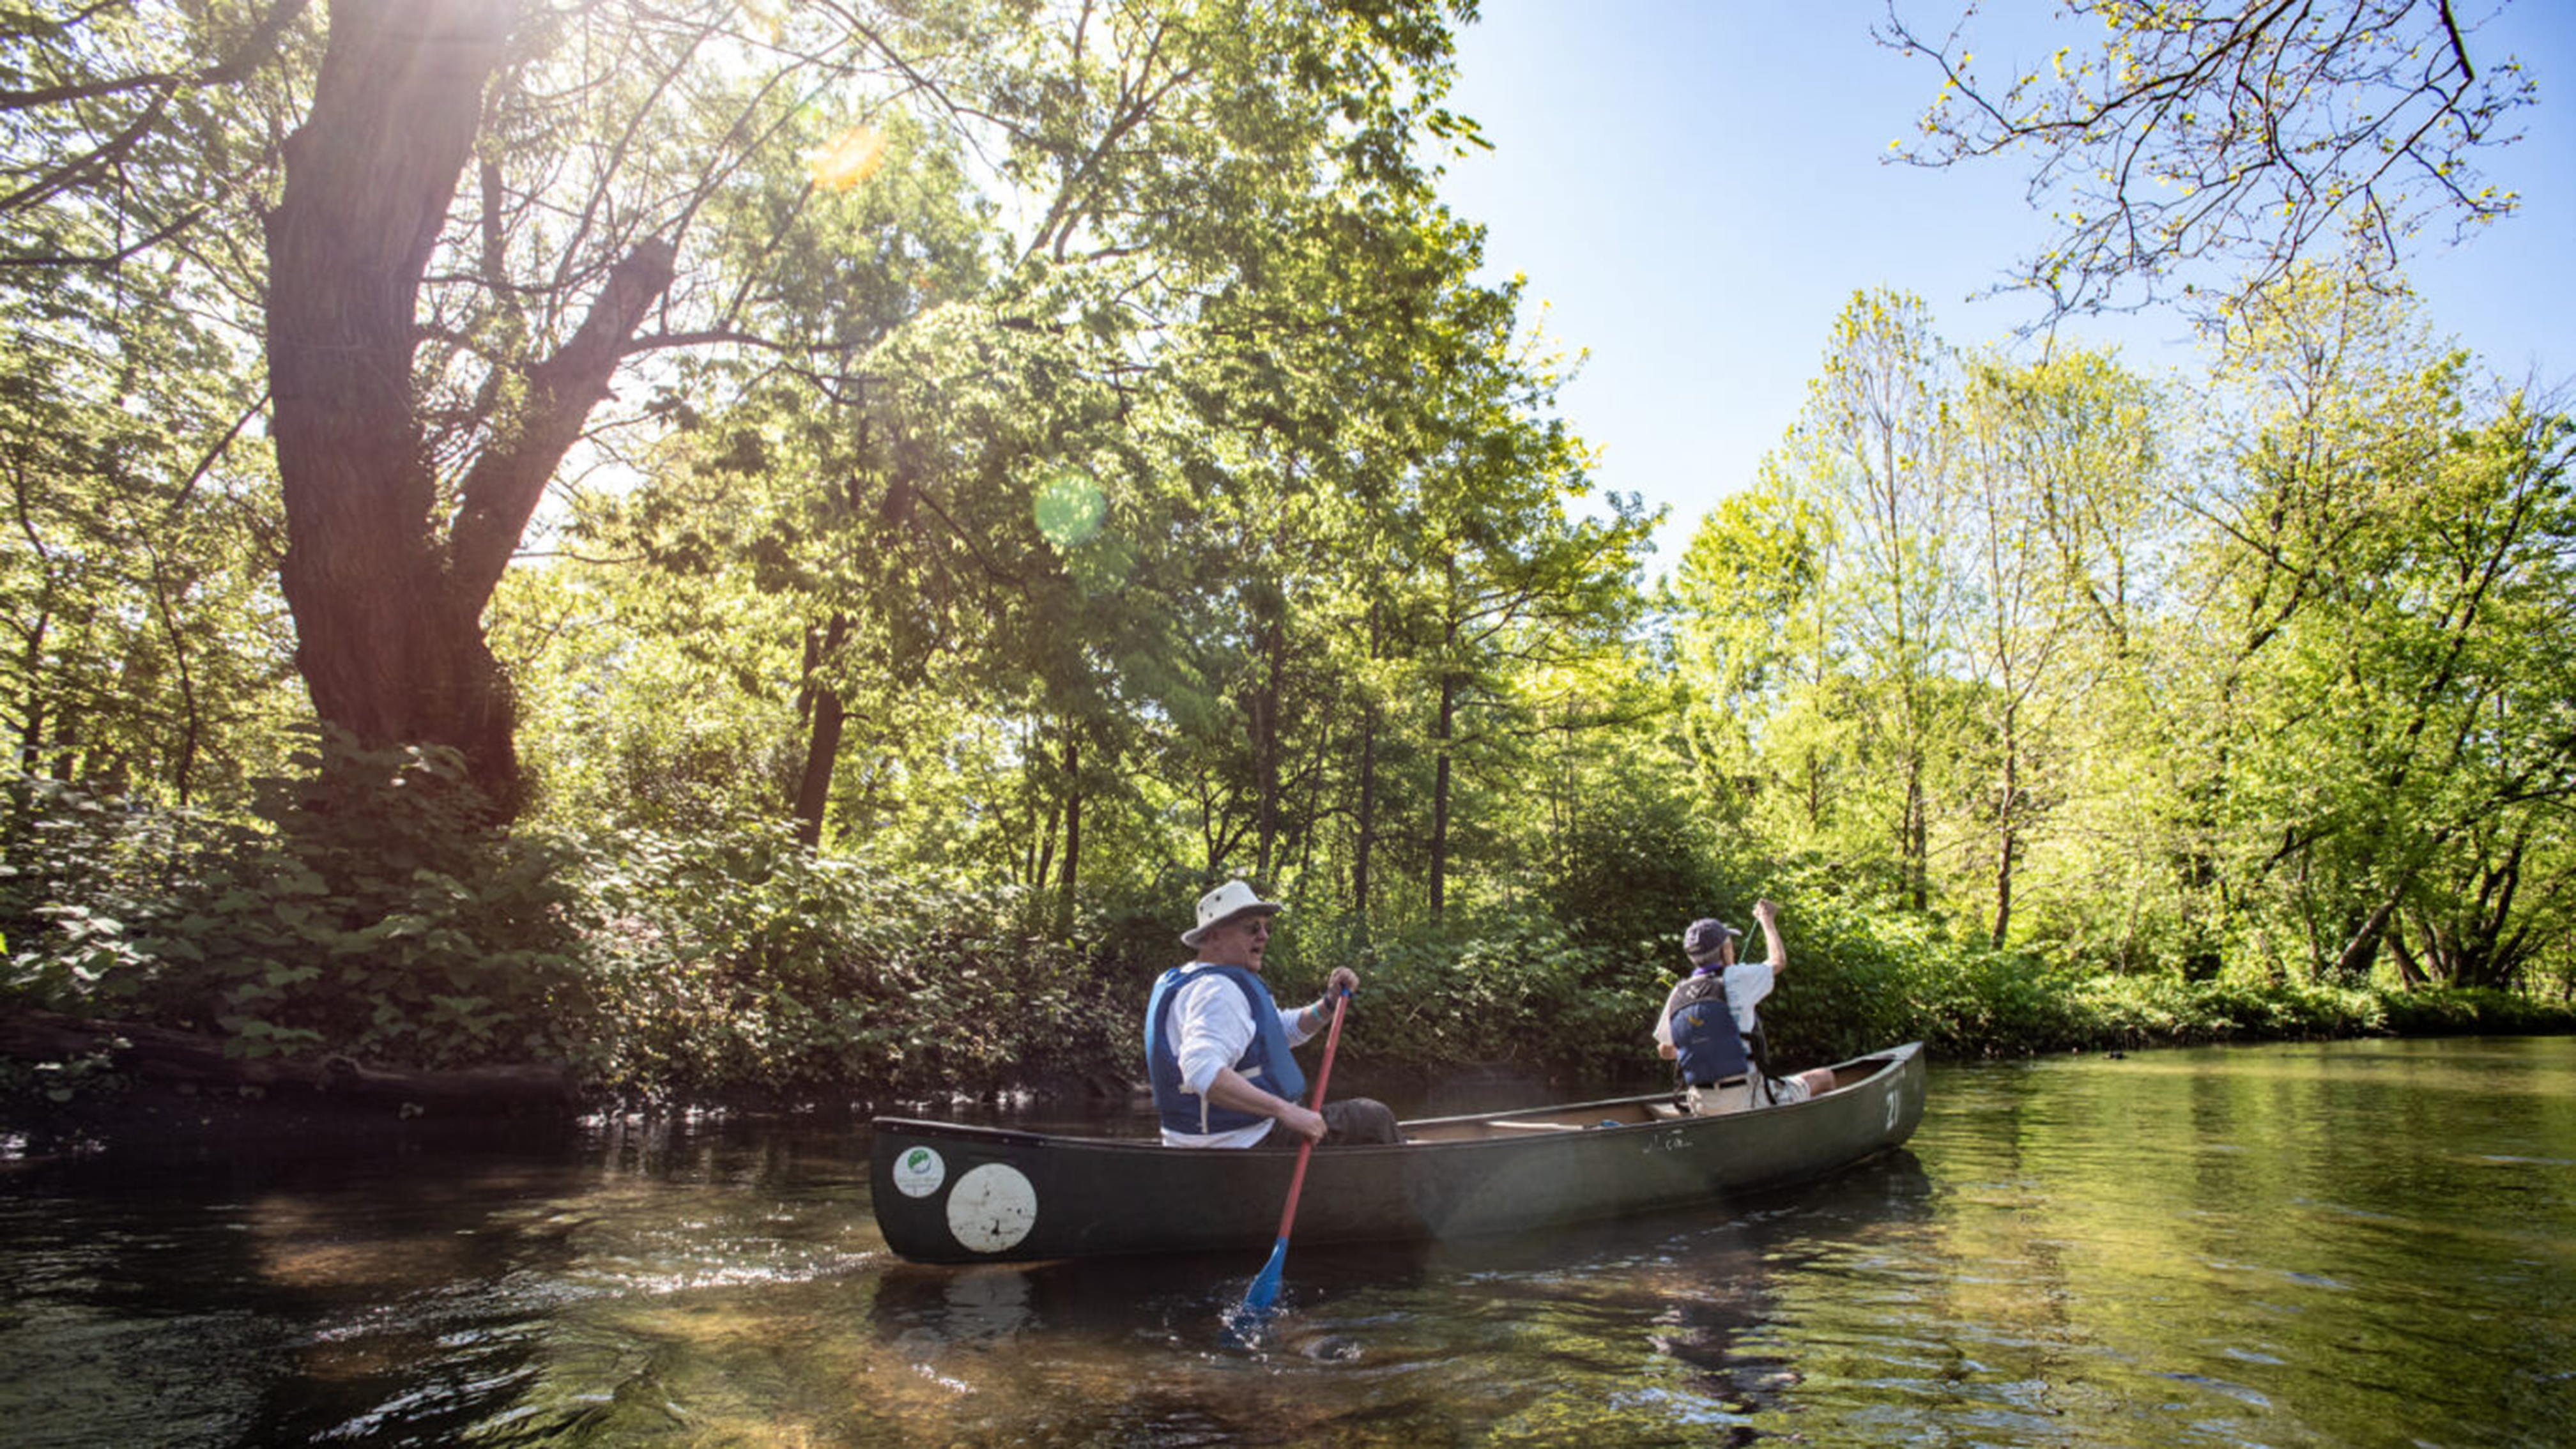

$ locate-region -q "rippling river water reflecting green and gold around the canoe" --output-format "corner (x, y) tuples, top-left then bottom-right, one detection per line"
(0, 1039), (2576, 1449)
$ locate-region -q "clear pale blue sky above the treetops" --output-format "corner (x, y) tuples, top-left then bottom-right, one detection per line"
(1443, 0), (2576, 572)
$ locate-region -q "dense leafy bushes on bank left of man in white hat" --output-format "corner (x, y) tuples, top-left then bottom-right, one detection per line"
(0, 747), (1131, 1096)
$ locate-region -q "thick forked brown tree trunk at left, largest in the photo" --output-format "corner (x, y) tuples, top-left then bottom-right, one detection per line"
(265, 0), (672, 815)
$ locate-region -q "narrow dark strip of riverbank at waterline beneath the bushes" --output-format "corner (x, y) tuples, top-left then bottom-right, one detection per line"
(0, 980), (2576, 1137)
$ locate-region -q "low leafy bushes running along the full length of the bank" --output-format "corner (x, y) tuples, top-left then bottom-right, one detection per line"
(0, 753), (2576, 1116)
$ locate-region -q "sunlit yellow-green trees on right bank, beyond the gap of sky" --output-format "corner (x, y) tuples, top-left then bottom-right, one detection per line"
(1672, 268), (2576, 1010)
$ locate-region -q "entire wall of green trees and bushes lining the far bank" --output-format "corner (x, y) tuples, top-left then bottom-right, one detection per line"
(0, 0), (2576, 1119)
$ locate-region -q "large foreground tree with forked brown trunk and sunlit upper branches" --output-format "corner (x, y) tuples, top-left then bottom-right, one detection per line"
(0, 0), (1483, 807)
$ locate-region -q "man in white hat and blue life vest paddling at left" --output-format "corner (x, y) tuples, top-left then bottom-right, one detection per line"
(1144, 879), (1399, 1147)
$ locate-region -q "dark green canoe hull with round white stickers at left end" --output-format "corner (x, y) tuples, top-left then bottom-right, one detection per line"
(871, 1044), (1924, 1263)
